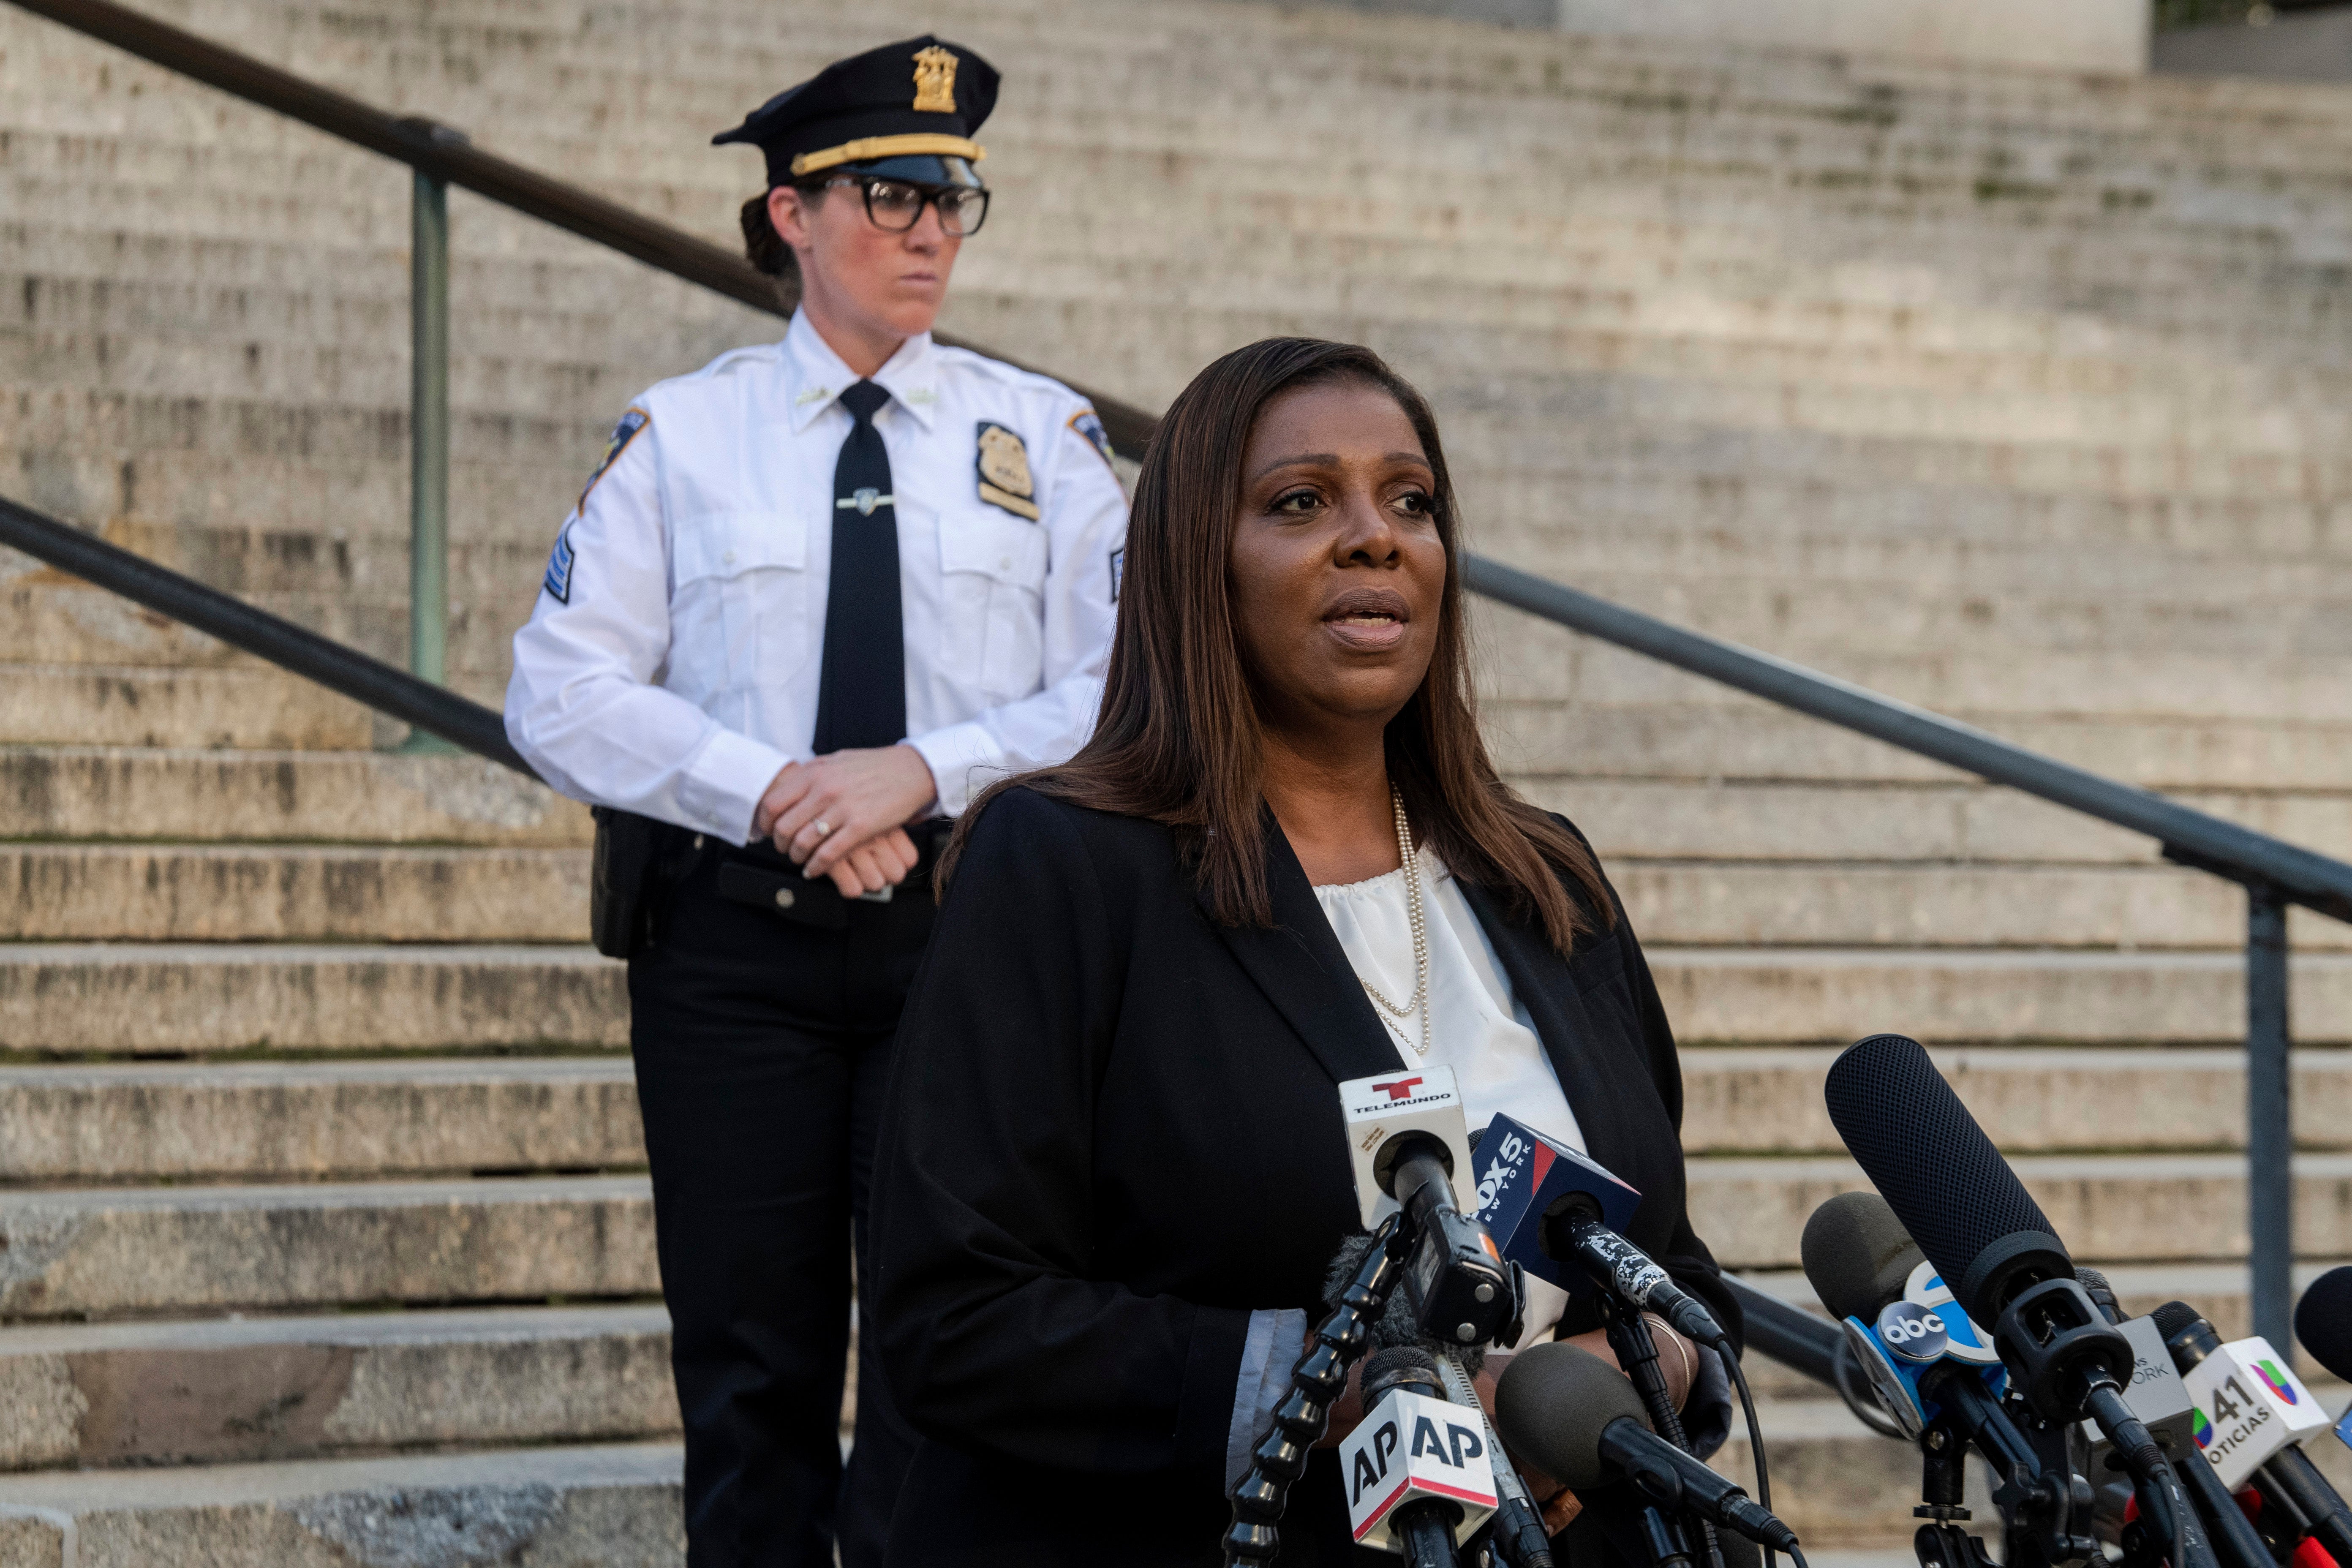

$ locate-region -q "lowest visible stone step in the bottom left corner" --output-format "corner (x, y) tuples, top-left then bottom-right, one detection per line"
(0, 1443), (687, 1568)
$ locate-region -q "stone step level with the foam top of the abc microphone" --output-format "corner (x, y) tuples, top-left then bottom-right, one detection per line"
(1689, 1154), (2352, 1269)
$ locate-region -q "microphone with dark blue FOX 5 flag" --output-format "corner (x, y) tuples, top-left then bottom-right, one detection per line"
(1477, 1116), (1731, 1349)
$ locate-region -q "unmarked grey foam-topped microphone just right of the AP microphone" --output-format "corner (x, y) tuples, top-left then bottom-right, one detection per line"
(1494, 1340), (1797, 1552)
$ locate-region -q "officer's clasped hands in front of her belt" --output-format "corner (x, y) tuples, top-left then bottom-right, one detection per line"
(753, 745), (939, 898)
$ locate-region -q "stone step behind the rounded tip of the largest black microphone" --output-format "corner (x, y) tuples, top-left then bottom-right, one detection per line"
(1682, 1046), (2352, 1154)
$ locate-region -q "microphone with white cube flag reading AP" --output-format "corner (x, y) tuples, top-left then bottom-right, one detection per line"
(1338, 1345), (1496, 1568)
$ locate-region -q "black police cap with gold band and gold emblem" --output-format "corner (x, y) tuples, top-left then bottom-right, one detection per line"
(710, 33), (997, 186)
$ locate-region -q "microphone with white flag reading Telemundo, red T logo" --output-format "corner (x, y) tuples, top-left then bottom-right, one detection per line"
(1338, 1065), (1522, 1345)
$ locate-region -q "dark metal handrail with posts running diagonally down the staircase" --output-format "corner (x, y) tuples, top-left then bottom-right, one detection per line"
(0, 0), (2352, 1345)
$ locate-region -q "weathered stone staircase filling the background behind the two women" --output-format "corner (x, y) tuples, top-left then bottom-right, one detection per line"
(14, 0), (2352, 1568)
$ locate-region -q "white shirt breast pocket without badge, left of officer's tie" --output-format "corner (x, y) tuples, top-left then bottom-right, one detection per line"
(670, 510), (811, 686)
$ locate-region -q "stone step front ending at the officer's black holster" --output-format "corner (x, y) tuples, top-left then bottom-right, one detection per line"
(0, 844), (588, 943)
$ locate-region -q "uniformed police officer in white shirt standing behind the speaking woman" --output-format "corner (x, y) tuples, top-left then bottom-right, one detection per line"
(506, 38), (1127, 1568)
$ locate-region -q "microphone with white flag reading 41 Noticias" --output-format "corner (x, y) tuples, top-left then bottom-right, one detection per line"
(2152, 1302), (2352, 1563)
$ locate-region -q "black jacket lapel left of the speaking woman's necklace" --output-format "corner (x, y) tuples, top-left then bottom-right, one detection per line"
(1195, 814), (1402, 1084)
